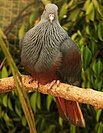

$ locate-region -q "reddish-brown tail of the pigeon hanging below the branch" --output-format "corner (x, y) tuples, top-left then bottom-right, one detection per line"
(56, 97), (85, 127)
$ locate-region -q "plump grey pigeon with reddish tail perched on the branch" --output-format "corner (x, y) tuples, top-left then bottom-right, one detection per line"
(20, 3), (85, 127)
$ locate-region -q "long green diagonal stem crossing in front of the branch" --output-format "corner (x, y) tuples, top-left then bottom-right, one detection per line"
(0, 35), (36, 133)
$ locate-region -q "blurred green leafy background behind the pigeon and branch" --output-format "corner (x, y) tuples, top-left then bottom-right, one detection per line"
(0, 0), (103, 133)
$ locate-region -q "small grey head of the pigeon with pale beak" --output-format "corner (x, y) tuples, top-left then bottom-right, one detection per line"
(41, 4), (58, 23)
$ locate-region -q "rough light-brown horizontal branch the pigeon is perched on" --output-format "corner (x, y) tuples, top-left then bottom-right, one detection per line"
(0, 75), (103, 109)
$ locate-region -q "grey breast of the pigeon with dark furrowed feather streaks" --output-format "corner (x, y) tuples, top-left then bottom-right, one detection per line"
(21, 22), (68, 73)
